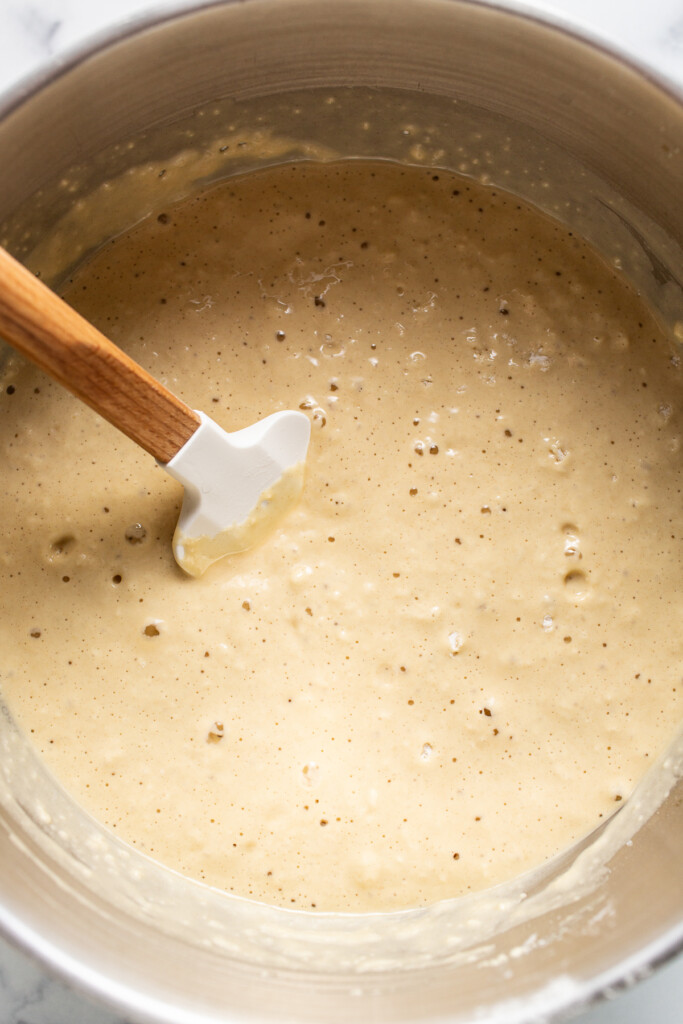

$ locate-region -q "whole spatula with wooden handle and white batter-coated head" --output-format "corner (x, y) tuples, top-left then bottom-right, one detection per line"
(0, 249), (310, 577)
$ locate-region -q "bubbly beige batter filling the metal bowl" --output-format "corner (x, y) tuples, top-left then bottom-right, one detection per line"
(0, 162), (683, 910)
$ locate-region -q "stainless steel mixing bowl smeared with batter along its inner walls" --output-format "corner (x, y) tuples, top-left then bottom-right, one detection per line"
(0, 0), (683, 1024)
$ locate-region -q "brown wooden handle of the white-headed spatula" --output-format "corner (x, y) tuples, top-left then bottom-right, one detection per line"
(0, 248), (200, 462)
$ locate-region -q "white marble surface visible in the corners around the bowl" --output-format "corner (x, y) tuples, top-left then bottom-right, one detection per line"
(0, 0), (683, 1024)
